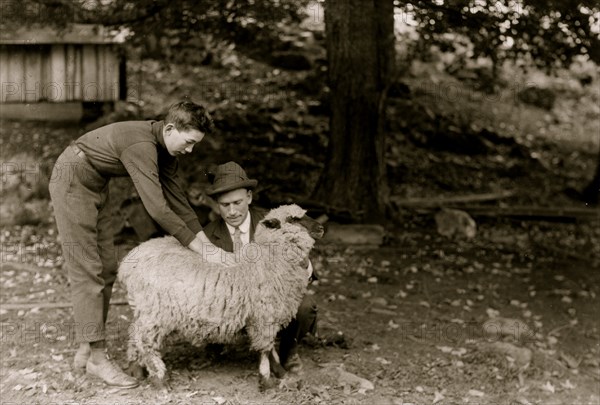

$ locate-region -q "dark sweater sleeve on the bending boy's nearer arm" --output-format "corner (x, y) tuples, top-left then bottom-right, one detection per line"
(120, 142), (199, 246)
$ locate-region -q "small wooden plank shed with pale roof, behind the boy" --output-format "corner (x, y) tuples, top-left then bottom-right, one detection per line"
(0, 24), (126, 120)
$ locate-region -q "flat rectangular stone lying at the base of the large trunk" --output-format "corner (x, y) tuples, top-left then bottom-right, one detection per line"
(319, 223), (385, 248)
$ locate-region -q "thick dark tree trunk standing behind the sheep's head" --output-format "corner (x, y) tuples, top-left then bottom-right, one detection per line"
(313, 0), (395, 222)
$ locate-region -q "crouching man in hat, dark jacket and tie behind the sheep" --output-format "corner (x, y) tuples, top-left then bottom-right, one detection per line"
(204, 162), (317, 372)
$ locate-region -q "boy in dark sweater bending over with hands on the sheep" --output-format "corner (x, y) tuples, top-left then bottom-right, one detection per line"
(49, 102), (232, 388)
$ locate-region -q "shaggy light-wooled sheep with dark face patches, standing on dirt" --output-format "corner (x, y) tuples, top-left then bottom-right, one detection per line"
(118, 204), (324, 390)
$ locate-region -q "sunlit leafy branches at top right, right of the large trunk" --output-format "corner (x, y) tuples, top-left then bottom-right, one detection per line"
(404, 0), (600, 68)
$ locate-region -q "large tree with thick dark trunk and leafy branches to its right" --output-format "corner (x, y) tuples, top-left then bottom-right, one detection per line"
(313, 0), (600, 221)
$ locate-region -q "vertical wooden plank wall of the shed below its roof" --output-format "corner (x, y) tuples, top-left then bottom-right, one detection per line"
(0, 44), (119, 103)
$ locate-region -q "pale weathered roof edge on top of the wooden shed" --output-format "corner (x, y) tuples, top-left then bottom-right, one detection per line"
(0, 24), (124, 45)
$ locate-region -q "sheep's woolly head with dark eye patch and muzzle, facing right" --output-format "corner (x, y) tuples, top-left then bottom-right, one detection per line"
(255, 204), (324, 254)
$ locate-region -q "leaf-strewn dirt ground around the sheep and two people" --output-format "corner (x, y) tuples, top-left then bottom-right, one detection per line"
(0, 216), (600, 405)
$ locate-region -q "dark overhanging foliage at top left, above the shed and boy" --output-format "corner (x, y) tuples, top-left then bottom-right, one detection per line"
(0, 0), (309, 58)
